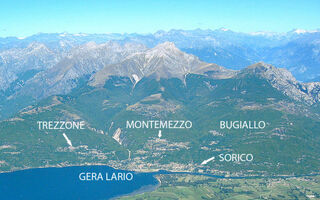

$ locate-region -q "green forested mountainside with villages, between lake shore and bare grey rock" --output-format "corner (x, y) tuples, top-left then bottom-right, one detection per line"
(0, 74), (320, 175)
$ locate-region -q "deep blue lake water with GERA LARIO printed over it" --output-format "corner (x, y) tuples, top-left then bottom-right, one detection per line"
(0, 166), (159, 200)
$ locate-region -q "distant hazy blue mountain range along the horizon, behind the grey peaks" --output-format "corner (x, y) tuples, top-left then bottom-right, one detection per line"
(0, 28), (320, 81)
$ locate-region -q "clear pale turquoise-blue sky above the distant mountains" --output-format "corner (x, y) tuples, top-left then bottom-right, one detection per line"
(0, 0), (320, 37)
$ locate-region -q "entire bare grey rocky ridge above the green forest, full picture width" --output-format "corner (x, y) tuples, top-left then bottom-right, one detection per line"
(2, 42), (320, 120)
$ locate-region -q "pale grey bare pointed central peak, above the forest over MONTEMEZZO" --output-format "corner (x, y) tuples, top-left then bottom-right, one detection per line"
(90, 42), (233, 86)
